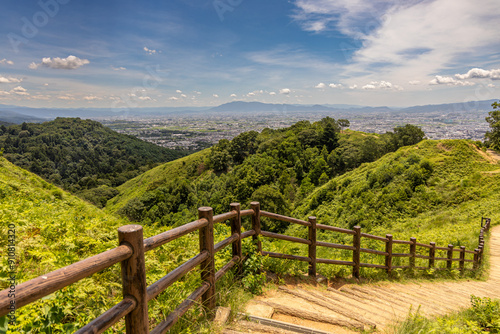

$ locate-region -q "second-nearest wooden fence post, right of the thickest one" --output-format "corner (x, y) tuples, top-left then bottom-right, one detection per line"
(198, 206), (215, 311)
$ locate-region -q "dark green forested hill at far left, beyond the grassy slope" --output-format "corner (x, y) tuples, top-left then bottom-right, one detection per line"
(0, 118), (186, 207)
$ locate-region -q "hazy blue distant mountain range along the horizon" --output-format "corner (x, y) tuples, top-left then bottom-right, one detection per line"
(0, 99), (498, 124)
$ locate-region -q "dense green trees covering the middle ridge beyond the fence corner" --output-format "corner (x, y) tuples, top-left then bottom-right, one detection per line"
(108, 117), (424, 231)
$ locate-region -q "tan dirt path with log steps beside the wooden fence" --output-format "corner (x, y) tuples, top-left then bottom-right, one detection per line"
(227, 226), (500, 334)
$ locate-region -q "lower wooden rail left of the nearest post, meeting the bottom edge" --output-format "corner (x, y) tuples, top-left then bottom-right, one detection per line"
(74, 298), (137, 334)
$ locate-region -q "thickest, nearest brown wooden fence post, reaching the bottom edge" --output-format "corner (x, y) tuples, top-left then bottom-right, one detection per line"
(118, 225), (149, 334)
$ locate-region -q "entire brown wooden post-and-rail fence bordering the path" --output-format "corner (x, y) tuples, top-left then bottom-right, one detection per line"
(0, 202), (490, 334)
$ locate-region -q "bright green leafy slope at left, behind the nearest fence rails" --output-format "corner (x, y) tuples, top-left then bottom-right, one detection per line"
(0, 157), (237, 334)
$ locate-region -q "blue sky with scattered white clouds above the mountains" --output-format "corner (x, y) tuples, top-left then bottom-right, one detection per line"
(0, 0), (500, 108)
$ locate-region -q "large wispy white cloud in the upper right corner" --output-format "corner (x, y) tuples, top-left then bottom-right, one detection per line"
(293, 0), (500, 86)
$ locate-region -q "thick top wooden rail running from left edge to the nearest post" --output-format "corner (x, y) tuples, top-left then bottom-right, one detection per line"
(0, 245), (132, 317)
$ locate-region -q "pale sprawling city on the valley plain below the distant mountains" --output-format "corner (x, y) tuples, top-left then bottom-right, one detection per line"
(99, 104), (488, 151)
